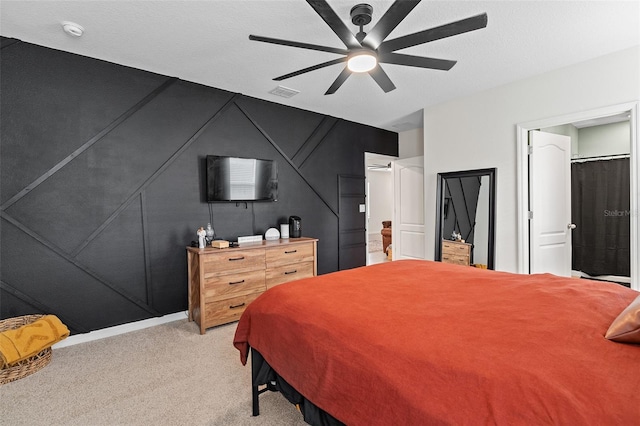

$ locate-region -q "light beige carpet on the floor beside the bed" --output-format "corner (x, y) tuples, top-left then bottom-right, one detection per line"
(0, 318), (306, 426)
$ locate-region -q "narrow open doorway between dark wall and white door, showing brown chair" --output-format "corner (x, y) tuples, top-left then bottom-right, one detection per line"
(364, 152), (397, 265)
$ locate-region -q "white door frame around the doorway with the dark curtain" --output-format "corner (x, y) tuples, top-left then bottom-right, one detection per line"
(516, 102), (640, 291)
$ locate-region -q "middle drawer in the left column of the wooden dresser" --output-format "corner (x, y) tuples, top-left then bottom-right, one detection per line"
(204, 270), (265, 303)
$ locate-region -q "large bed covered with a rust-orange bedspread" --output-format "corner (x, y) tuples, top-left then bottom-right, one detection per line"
(234, 260), (640, 425)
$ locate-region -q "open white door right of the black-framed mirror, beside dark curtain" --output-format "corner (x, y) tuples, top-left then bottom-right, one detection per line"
(529, 130), (573, 277)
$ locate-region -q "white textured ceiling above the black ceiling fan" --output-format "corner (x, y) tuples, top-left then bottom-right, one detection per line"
(0, 0), (640, 131)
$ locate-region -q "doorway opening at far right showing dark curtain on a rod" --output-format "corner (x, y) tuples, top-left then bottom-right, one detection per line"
(540, 112), (631, 287)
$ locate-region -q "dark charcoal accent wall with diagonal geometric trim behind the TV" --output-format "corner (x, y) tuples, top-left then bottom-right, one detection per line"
(0, 38), (398, 333)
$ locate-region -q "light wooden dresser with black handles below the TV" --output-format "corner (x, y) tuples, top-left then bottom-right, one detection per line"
(187, 238), (318, 334)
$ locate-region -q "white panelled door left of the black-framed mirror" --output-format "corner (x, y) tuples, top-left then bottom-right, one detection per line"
(391, 157), (425, 260)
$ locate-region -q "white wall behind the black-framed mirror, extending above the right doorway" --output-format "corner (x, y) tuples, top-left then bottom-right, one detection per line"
(424, 46), (640, 272)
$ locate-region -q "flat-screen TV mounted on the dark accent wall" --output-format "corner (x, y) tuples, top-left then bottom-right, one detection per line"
(207, 155), (278, 203)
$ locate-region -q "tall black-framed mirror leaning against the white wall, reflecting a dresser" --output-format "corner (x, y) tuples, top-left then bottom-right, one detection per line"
(435, 168), (496, 269)
